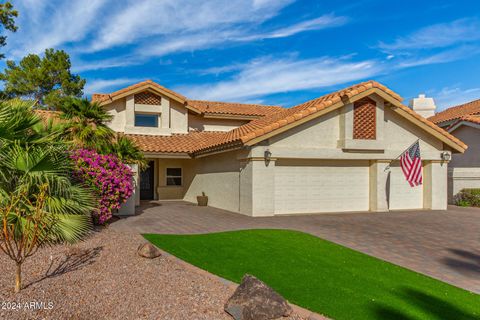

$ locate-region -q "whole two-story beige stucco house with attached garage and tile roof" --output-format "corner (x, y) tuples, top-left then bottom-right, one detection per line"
(92, 81), (467, 216)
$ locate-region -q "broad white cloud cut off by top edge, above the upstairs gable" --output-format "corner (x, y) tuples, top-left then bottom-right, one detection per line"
(91, 0), (293, 51)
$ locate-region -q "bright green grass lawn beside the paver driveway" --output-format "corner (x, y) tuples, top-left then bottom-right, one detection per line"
(144, 230), (480, 320)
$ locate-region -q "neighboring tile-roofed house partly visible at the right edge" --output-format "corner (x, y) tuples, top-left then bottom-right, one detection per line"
(429, 99), (480, 202)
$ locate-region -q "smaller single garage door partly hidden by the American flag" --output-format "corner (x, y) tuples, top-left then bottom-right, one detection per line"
(389, 164), (423, 210)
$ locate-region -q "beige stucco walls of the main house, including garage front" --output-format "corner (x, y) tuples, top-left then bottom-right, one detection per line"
(107, 89), (454, 216)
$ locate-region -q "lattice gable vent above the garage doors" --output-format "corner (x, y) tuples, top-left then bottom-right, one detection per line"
(353, 98), (377, 140)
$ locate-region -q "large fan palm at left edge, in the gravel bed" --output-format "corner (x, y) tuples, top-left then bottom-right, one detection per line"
(0, 100), (95, 292)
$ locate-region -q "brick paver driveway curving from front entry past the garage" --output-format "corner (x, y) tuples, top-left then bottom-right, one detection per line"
(111, 201), (480, 293)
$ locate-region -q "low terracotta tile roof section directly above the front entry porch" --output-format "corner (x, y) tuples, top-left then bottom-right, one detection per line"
(126, 131), (225, 153)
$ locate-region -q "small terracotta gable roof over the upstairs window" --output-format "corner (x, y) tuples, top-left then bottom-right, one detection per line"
(92, 80), (187, 105)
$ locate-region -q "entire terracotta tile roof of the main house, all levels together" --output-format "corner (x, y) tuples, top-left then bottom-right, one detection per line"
(83, 80), (467, 155)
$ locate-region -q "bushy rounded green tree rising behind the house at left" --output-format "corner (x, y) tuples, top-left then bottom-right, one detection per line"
(0, 49), (85, 109)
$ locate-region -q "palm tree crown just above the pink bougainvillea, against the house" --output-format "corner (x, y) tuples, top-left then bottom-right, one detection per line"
(60, 98), (114, 149)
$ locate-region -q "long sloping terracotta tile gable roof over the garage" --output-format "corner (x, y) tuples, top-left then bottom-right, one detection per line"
(192, 80), (467, 155)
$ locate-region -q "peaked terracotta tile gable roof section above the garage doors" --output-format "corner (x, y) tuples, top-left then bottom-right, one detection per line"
(193, 81), (467, 152)
